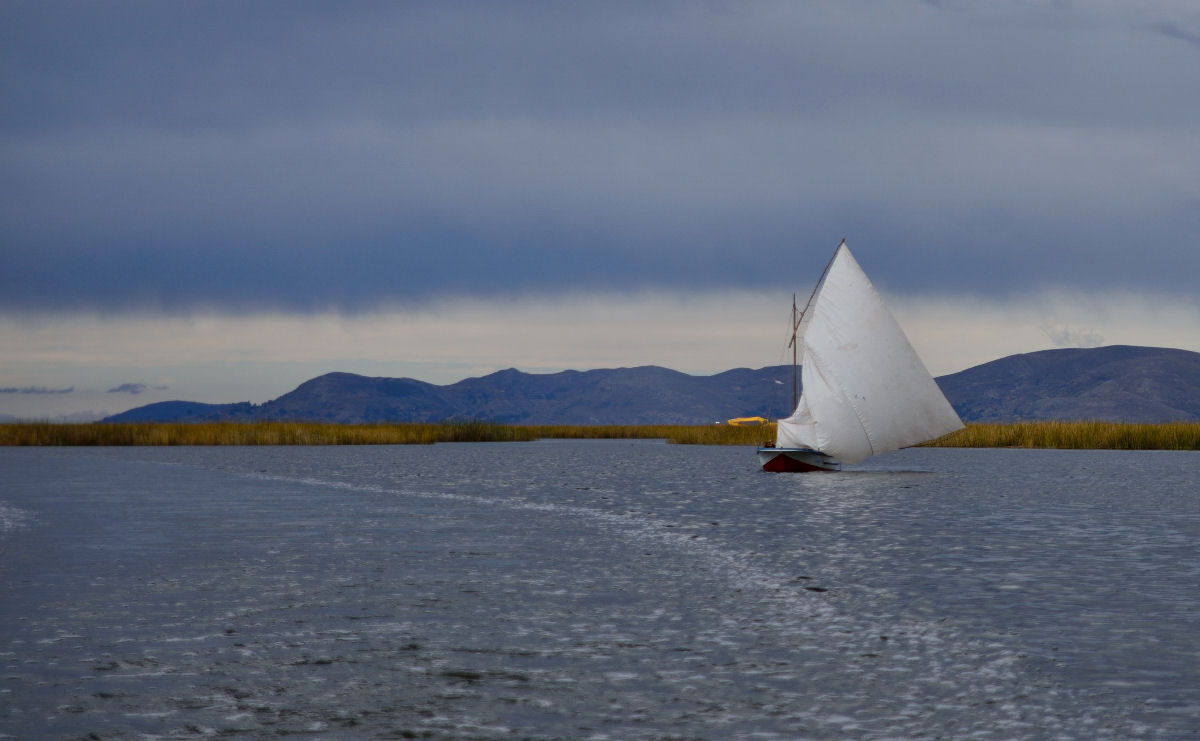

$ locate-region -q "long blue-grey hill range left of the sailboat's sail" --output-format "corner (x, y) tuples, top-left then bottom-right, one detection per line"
(104, 366), (792, 424)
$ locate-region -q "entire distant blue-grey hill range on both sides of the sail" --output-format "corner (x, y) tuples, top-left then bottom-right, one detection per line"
(106, 347), (1200, 424)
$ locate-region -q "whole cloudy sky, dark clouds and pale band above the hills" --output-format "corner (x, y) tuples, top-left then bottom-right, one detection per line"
(0, 0), (1200, 416)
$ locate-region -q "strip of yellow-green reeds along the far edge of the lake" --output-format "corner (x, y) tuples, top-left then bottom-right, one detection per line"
(0, 421), (1200, 451)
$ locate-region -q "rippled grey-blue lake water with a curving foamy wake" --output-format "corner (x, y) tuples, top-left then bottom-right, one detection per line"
(0, 441), (1200, 741)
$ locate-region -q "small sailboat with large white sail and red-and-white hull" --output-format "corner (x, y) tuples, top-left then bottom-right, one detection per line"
(758, 240), (962, 472)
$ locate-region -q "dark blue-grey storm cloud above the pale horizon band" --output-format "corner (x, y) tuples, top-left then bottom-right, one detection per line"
(0, 1), (1200, 311)
